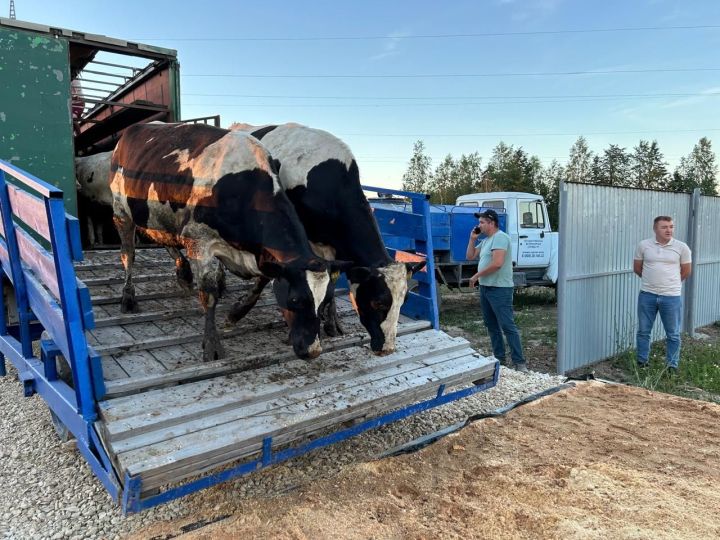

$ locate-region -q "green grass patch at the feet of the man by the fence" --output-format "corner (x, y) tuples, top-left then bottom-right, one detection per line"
(613, 339), (720, 401)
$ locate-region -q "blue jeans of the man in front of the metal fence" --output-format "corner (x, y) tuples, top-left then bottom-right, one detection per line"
(637, 291), (682, 368)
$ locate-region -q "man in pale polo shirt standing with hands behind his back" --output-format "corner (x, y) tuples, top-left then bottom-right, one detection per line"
(633, 216), (692, 373)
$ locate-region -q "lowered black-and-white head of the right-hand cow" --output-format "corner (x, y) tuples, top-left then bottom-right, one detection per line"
(348, 261), (425, 355)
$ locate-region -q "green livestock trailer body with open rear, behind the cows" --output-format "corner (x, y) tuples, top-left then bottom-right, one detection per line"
(0, 18), (180, 215)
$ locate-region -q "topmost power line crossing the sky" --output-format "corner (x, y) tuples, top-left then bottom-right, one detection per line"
(133, 24), (720, 42)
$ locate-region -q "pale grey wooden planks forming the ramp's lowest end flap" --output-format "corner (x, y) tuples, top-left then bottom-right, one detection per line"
(95, 330), (495, 488)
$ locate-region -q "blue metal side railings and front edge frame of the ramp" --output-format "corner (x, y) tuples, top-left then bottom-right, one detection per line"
(0, 167), (499, 512)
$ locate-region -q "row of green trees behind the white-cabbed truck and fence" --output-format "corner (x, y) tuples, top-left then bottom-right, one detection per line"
(403, 136), (718, 226)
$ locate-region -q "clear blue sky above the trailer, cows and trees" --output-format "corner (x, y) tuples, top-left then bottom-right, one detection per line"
(9, 0), (720, 187)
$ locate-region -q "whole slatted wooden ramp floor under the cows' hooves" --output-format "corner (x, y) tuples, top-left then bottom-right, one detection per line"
(76, 249), (498, 510)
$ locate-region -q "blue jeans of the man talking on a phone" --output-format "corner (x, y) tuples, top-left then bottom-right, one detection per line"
(480, 285), (525, 364)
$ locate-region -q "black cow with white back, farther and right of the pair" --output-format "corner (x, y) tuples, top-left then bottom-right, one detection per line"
(229, 123), (425, 355)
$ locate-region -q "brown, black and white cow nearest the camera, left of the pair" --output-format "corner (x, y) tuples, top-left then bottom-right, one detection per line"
(110, 123), (338, 361)
